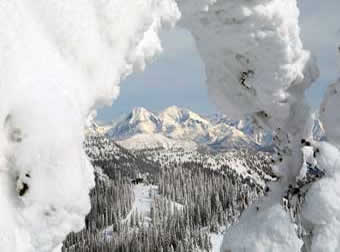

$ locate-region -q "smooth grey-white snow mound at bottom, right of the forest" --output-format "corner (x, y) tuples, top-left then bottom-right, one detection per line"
(221, 203), (302, 252)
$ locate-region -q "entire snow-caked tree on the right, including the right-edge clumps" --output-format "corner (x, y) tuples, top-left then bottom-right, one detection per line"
(174, 0), (340, 252)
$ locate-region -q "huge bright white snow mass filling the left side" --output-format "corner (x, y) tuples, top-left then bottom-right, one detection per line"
(0, 0), (179, 252)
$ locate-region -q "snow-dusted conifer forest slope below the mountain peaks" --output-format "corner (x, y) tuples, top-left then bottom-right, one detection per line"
(63, 133), (273, 252)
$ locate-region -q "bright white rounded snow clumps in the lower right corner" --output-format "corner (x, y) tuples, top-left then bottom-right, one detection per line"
(302, 142), (340, 252)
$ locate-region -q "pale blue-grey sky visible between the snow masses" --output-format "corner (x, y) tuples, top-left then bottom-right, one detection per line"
(97, 0), (340, 122)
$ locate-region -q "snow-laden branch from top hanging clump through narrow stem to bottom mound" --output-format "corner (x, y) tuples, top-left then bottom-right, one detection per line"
(178, 0), (319, 252)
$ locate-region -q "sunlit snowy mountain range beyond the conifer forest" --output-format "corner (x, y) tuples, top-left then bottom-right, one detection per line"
(106, 106), (272, 151)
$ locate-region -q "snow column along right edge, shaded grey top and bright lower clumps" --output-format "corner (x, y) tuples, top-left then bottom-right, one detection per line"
(303, 43), (340, 252)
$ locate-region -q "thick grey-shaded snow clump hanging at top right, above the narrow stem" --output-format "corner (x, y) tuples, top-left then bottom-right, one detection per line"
(179, 0), (318, 125)
